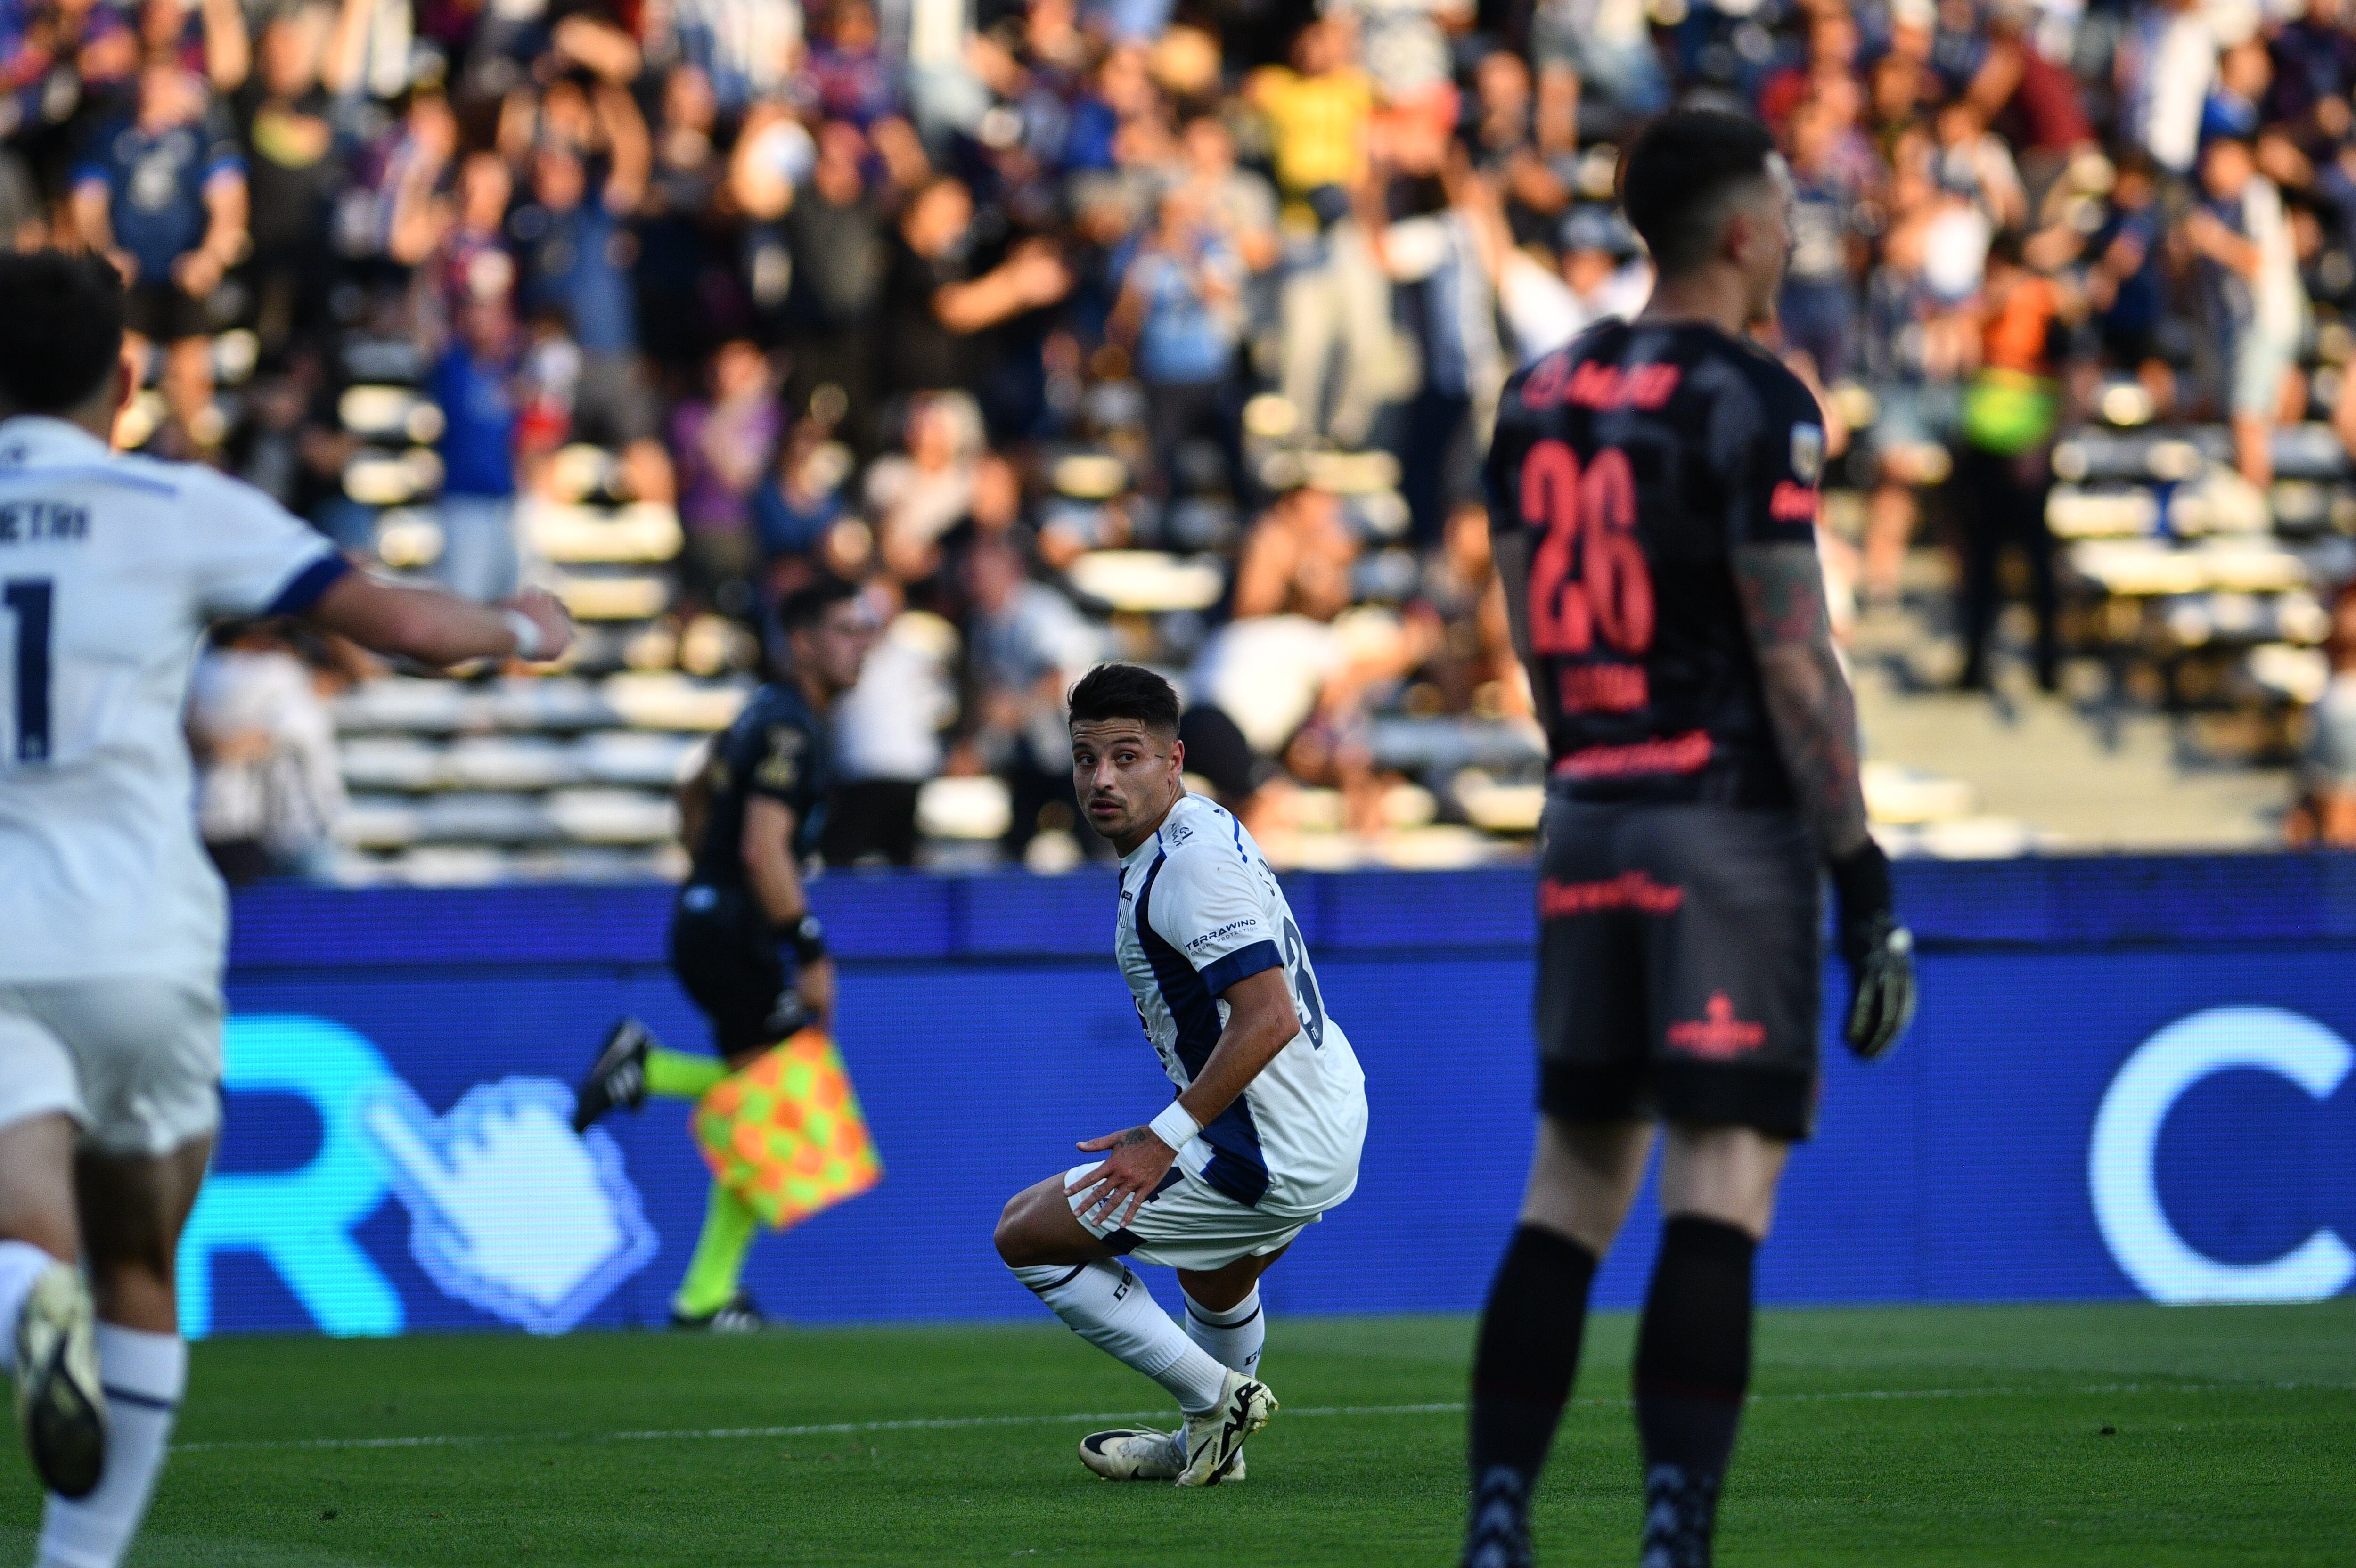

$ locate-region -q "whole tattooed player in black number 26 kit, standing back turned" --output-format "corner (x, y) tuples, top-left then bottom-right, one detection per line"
(1463, 113), (1915, 1568)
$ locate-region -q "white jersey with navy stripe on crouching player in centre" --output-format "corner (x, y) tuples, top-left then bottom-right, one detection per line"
(1112, 796), (1366, 1212)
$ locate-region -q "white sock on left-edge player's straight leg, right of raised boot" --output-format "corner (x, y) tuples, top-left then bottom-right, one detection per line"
(38, 1323), (188, 1568)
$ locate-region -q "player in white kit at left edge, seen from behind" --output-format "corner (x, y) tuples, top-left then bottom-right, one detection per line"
(0, 252), (573, 1568)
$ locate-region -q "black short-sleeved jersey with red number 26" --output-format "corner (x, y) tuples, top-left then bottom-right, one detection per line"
(1487, 320), (1824, 805)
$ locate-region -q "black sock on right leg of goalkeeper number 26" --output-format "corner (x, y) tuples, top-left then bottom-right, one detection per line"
(1635, 1215), (1758, 1568)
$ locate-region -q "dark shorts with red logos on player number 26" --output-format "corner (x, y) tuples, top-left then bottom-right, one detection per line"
(1538, 798), (1824, 1140)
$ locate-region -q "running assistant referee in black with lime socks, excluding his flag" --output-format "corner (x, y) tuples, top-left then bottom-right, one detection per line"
(573, 579), (876, 1330)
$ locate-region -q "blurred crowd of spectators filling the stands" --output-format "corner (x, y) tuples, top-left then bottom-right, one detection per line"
(14, 0), (2356, 859)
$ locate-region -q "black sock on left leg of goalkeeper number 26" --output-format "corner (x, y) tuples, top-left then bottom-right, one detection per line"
(1465, 1224), (1595, 1568)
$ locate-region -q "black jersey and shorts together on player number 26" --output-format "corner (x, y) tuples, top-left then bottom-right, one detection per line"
(1487, 323), (1824, 1137)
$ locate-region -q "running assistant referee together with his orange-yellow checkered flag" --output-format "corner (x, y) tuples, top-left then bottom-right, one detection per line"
(573, 577), (881, 1332)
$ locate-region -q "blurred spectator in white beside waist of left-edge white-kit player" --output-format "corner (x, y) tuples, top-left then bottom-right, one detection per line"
(188, 624), (344, 883)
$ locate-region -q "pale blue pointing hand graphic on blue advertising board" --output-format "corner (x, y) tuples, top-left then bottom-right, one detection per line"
(360, 1078), (655, 1335)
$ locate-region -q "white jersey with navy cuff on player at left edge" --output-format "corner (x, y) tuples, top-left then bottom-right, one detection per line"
(0, 416), (346, 984)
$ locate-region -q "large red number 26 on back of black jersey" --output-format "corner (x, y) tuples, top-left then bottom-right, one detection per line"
(1522, 440), (1652, 654)
